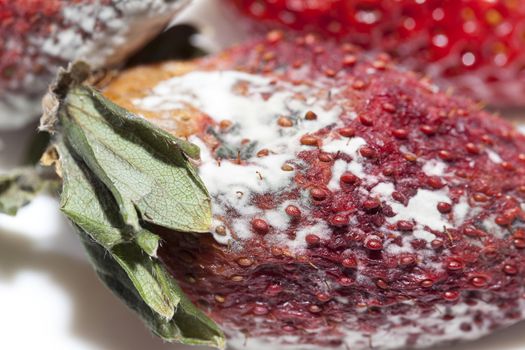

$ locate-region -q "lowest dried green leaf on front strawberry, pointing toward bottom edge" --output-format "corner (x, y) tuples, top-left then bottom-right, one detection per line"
(79, 228), (226, 349)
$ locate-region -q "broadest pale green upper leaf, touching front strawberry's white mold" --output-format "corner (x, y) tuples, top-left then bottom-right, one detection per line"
(59, 86), (211, 232)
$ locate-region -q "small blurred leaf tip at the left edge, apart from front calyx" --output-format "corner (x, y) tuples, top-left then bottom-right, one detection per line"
(0, 167), (56, 215)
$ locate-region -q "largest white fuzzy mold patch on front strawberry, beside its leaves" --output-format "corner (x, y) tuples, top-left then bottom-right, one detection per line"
(133, 70), (342, 252)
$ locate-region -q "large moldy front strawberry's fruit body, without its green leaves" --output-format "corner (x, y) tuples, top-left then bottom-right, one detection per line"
(106, 32), (525, 349)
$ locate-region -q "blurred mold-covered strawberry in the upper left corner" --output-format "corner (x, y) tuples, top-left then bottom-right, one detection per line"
(0, 0), (186, 128)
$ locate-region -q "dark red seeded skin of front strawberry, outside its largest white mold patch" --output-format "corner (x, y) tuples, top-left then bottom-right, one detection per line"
(144, 32), (525, 349)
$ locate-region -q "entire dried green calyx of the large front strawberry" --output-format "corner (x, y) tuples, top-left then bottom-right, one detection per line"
(41, 63), (225, 349)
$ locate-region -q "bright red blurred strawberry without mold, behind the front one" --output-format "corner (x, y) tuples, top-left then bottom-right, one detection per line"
(233, 0), (525, 106)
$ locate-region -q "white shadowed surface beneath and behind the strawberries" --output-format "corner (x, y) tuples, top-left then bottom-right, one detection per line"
(0, 0), (525, 350)
